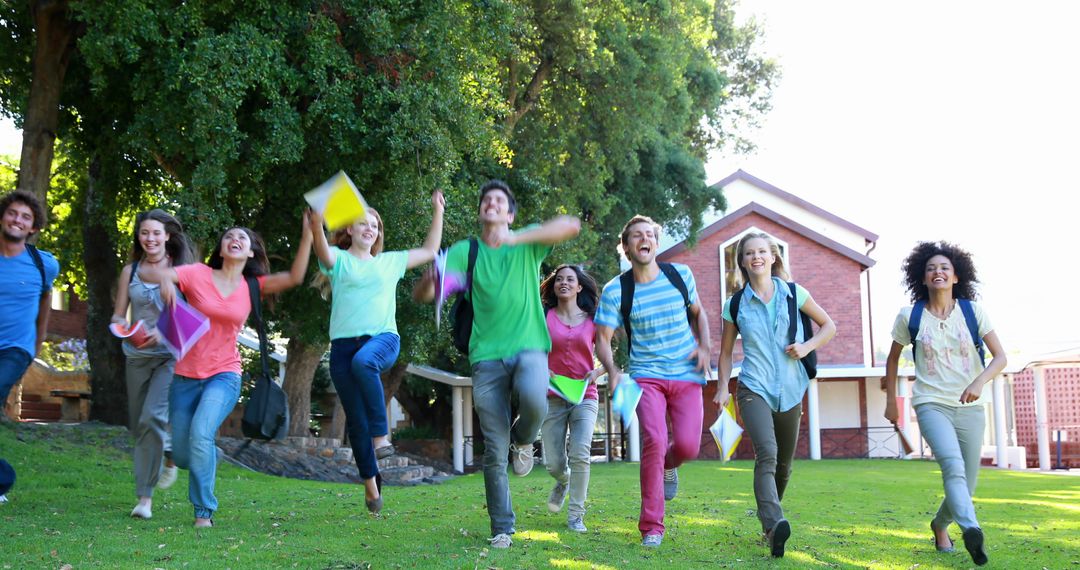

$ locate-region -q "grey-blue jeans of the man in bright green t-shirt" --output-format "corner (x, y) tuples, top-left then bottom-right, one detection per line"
(472, 351), (550, 537)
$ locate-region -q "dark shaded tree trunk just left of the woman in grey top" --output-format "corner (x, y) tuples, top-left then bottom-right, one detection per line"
(82, 155), (127, 425)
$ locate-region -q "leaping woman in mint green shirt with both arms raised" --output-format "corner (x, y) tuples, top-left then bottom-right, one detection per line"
(311, 190), (445, 513)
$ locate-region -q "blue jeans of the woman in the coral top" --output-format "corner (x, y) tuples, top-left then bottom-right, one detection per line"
(168, 372), (240, 518)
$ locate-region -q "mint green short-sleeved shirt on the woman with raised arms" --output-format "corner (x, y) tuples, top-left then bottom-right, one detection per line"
(319, 247), (408, 340)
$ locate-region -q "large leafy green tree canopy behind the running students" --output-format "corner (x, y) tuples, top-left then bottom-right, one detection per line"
(0, 0), (775, 433)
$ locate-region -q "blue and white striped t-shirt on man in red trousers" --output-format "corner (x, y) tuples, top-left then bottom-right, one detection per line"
(594, 263), (705, 384)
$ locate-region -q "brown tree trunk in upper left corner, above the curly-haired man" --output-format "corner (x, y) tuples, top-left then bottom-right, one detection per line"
(17, 0), (79, 205)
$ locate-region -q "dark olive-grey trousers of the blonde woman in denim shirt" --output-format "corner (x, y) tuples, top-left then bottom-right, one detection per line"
(735, 383), (802, 532)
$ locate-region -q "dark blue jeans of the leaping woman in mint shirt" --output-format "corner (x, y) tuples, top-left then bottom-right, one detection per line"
(330, 333), (401, 479)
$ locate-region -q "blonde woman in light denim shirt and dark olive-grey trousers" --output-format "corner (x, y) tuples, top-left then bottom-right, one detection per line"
(714, 233), (836, 557)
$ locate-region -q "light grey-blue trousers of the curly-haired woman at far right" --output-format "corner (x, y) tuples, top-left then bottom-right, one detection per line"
(915, 403), (986, 530)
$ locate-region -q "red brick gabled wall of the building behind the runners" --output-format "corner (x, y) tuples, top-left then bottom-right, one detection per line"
(669, 214), (863, 365)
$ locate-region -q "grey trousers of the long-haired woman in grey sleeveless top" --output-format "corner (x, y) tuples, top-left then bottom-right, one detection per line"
(124, 356), (176, 497)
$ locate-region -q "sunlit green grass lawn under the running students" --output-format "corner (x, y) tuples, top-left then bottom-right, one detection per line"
(0, 425), (1080, 569)
